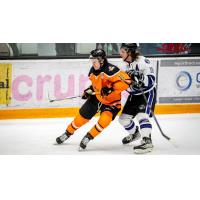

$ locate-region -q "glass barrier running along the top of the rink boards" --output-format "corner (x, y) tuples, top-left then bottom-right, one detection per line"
(0, 43), (200, 59)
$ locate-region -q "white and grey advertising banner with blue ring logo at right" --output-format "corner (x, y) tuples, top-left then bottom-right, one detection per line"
(158, 58), (200, 104)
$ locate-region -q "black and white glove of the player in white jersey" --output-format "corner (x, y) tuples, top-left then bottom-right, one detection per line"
(126, 70), (144, 88)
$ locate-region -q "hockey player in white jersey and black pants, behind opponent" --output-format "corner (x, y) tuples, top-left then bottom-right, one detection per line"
(119, 43), (156, 154)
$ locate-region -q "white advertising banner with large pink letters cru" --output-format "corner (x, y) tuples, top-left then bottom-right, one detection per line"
(0, 59), (157, 109)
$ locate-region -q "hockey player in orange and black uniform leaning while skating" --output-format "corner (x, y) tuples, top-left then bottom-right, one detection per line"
(56, 49), (131, 149)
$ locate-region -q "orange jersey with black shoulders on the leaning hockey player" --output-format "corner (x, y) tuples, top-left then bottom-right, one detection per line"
(89, 63), (131, 106)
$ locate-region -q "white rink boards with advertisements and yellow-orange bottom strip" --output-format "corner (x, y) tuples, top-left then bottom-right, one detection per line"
(0, 57), (200, 119)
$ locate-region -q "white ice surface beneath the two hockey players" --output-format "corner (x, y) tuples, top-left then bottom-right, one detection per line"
(0, 114), (200, 155)
